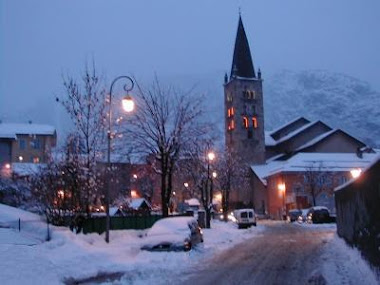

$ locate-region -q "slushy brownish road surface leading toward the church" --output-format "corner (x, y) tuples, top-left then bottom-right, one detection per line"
(181, 223), (335, 285)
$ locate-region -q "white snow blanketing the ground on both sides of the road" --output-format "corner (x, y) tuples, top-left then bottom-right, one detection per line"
(0, 204), (376, 284)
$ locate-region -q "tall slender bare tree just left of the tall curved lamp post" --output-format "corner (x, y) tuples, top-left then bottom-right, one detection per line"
(57, 61), (107, 214)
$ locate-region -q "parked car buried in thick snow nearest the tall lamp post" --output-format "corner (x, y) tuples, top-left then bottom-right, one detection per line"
(141, 217), (203, 251)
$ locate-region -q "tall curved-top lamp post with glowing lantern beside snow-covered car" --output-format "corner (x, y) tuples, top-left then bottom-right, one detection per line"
(105, 75), (135, 243)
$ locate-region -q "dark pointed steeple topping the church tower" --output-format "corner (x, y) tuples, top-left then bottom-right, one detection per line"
(230, 15), (256, 78)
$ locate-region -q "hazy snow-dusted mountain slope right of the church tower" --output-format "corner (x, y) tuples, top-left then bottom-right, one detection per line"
(264, 70), (380, 146)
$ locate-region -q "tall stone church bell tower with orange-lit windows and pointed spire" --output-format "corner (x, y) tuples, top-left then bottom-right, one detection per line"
(224, 16), (265, 165)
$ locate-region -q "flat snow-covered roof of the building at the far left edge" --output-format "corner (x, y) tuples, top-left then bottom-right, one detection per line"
(0, 123), (55, 139)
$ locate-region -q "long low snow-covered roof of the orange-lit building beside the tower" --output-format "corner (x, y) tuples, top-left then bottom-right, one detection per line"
(251, 152), (378, 182)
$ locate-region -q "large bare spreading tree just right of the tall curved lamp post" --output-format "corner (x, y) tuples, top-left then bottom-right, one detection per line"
(127, 79), (205, 216)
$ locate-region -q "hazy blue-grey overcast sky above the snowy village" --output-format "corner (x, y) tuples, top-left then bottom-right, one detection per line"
(0, 0), (380, 129)
